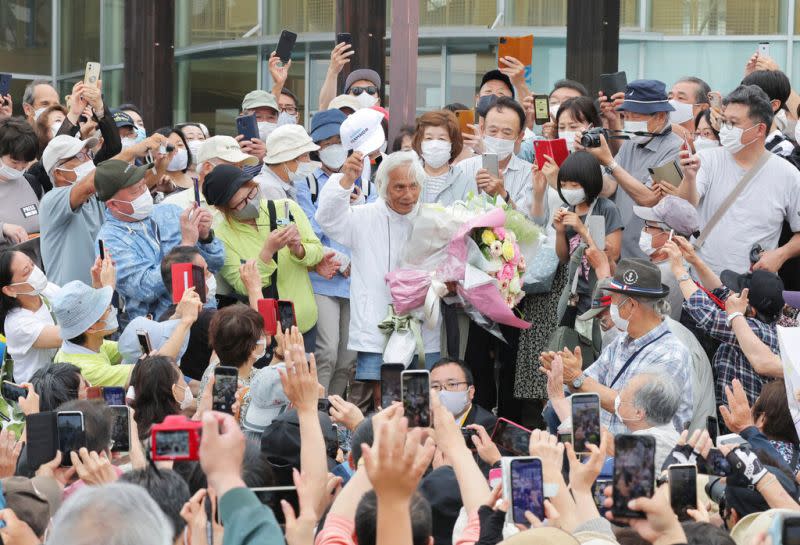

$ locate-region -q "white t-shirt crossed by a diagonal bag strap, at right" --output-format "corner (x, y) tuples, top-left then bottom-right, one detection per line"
(697, 147), (800, 274)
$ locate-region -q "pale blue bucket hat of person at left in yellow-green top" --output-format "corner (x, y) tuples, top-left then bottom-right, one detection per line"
(51, 280), (114, 339)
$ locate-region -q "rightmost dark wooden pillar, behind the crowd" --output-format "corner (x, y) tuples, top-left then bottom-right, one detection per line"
(567, 0), (620, 96)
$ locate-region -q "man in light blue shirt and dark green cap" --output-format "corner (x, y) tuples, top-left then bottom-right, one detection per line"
(94, 159), (224, 326)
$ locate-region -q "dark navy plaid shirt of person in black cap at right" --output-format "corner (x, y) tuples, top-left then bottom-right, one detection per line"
(683, 286), (779, 406)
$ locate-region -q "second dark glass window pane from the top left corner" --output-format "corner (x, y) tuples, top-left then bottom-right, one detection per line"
(59, 0), (100, 74)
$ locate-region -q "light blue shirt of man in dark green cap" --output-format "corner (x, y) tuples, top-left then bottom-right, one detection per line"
(95, 204), (225, 320)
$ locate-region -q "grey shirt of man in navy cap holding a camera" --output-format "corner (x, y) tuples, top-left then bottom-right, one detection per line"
(614, 132), (683, 258)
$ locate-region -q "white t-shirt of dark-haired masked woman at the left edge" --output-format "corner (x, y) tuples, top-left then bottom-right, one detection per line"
(5, 284), (58, 384)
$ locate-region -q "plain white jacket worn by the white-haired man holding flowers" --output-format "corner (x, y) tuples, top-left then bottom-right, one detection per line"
(315, 174), (440, 353)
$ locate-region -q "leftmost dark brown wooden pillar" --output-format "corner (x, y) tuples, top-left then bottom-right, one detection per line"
(123, 0), (175, 130)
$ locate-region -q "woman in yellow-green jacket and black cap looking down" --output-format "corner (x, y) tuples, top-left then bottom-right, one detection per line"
(203, 165), (322, 352)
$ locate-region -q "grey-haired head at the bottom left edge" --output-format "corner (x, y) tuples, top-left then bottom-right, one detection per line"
(46, 483), (172, 545)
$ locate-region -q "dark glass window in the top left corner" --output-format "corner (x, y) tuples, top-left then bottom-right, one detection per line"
(0, 0), (53, 74)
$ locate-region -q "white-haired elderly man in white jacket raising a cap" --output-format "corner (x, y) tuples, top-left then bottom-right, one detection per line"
(315, 151), (440, 401)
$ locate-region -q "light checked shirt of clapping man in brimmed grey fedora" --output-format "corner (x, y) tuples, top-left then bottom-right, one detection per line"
(586, 322), (693, 435)
